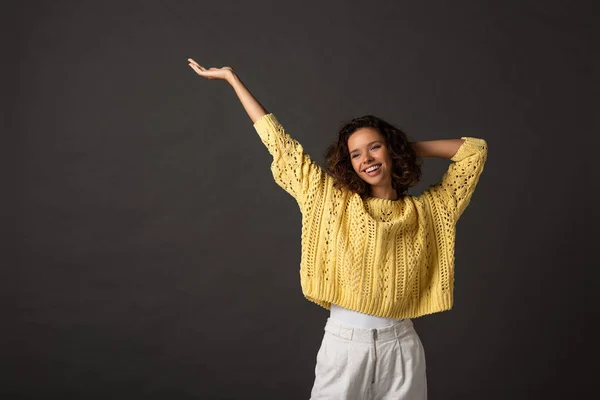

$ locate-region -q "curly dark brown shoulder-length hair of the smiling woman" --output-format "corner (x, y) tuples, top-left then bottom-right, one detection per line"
(325, 115), (422, 198)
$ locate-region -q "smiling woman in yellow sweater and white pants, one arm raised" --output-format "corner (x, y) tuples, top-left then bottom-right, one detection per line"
(188, 59), (487, 400)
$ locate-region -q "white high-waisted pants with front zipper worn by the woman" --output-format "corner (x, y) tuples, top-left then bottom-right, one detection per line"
(310, 318), (427, 400)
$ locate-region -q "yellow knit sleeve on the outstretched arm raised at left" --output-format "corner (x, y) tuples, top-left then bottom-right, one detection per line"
(254, 113), (326, 212)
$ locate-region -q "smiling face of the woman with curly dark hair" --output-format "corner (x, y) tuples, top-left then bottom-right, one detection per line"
(348, 128), (392, 187)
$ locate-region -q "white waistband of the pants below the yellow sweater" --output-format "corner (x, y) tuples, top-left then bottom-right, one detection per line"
(324, 317), (414, 343)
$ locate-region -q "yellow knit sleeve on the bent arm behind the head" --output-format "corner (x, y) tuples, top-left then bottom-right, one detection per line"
(428, 137), (488, 222)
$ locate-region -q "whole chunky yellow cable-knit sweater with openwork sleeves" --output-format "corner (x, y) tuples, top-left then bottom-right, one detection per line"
(254, 113), (487, 318)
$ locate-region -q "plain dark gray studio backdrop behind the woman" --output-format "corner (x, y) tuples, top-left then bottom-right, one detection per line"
(7, 0), (599, 399)
